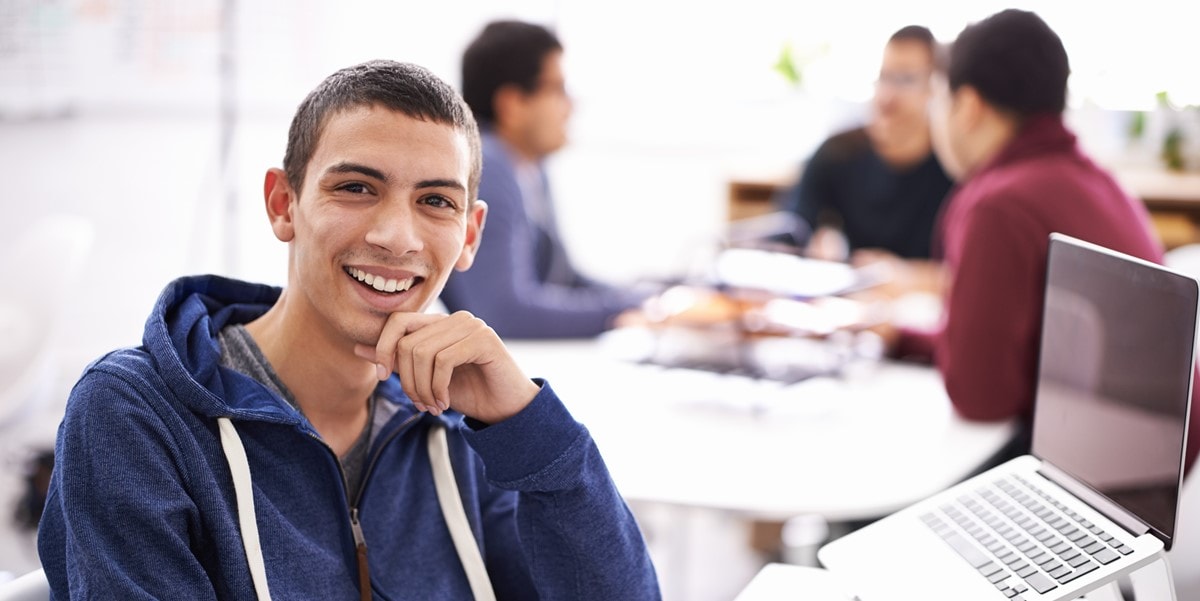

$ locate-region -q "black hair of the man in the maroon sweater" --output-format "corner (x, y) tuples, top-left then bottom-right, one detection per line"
(946, 8), (1070, 119)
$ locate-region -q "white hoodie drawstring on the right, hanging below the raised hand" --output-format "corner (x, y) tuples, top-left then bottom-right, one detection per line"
(428, 425), (496, 601)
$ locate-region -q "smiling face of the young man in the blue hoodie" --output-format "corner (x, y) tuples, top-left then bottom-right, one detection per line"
(274, 107), (486, 344)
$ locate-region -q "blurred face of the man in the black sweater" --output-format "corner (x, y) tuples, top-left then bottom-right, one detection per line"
(871, 40), (932, 142)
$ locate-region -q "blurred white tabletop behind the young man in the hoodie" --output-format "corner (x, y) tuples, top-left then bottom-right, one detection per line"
(509, 341), (1015, 521)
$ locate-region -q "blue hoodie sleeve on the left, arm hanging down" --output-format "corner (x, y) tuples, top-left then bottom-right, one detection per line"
(37, 369), (217, 600)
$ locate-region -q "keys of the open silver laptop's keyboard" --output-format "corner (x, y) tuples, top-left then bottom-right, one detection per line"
(920, 474), (1133, 601)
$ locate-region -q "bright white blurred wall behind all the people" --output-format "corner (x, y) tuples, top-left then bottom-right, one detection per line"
(0, 0), (1200, 364)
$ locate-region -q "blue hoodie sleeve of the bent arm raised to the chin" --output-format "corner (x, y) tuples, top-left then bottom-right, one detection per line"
(463, 383), (661, 601)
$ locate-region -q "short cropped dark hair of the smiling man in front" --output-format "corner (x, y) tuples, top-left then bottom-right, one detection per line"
(283, 60), (482, 200)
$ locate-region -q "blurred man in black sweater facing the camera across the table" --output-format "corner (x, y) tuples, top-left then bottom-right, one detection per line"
(779, 25), (950, 259)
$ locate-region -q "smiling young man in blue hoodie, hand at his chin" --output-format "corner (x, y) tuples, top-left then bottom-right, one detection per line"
(38, 61), (659, 600)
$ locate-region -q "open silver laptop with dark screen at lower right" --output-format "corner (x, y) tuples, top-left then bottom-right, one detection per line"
(817, 234), (1198, 601)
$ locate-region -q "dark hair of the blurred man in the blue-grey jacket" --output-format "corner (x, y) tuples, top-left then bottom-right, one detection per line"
(462, 20), (563, 126)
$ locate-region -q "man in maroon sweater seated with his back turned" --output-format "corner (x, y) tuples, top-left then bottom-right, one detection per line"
(931, 10), (1200, 467)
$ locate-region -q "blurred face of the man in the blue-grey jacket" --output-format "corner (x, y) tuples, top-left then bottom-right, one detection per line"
(518, 52), (571, 157)
